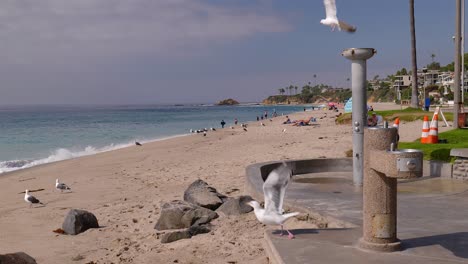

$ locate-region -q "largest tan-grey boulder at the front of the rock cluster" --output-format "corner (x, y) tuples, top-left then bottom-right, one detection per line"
(154, 201), (218, 230)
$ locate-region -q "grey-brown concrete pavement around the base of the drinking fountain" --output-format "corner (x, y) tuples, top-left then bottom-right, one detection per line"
(247, 166), (468, 264)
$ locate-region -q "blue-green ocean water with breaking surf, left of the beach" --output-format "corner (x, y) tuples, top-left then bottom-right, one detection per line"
(0, 104), (304, 173)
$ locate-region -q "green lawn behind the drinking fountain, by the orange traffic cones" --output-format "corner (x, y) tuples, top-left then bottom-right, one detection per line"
(398, 129), (468, 162)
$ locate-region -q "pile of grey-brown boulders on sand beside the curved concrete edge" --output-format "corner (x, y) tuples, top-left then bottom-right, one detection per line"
(154, 180), (253, 243)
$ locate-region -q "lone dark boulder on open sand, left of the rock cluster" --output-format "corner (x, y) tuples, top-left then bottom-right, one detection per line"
(62, 209), (99, 235)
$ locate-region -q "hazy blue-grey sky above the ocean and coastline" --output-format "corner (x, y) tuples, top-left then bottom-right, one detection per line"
(0, 0), (462, 105)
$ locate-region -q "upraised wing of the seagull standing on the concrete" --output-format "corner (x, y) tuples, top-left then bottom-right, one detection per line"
(263, 163), (292, 214)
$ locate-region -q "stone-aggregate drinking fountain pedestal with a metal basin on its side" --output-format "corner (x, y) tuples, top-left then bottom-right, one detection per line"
(359, 127), (423, 252)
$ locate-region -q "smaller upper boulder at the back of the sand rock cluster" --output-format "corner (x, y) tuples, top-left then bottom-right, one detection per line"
(184, 180), (227, 210)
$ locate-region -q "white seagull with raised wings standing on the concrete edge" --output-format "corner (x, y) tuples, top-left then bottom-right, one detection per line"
(247, 162), (299, 239)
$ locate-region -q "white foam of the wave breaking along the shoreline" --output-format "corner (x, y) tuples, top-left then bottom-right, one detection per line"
(0, 135), (186, 174)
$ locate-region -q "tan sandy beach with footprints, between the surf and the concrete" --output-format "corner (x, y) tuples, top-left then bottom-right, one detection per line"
(0, 104), (454, 263)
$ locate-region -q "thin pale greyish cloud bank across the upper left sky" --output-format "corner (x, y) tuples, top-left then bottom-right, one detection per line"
(0, 0), (290, 64)
